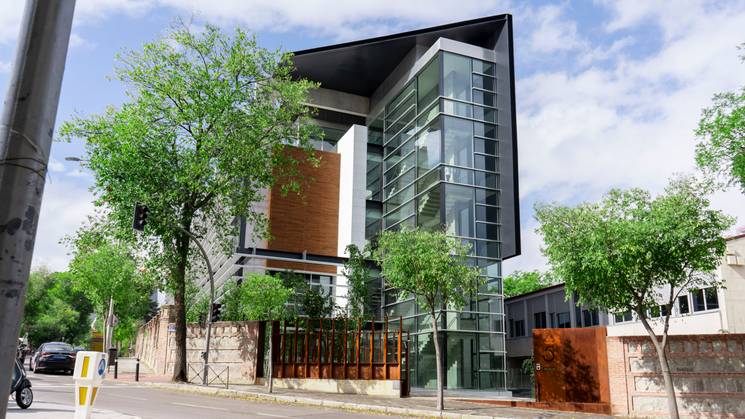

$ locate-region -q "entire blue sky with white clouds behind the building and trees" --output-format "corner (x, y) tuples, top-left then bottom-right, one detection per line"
(0, 0), (745, 274)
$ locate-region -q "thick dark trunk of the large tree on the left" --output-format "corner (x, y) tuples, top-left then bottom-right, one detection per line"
(171, 231), (189, 382)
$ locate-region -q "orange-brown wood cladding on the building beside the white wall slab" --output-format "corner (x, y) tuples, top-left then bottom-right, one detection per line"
(267, 148), (341, 273)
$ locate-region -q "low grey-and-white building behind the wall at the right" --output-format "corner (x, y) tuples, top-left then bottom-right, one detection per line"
(505, 234), (745, 391)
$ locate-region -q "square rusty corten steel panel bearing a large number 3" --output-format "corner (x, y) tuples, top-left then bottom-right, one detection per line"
(533, 327), (610, 403)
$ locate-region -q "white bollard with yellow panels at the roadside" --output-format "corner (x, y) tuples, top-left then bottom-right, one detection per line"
(73, 351), (107, 419)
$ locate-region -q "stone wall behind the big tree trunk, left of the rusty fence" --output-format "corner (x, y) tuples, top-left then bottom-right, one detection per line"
(135, 306), (259, 384)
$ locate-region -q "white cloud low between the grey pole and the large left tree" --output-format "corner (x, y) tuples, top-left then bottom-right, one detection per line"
(32, 177), (94, 270)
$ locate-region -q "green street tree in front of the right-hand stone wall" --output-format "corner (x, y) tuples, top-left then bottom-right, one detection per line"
(536, 177), (733, 418)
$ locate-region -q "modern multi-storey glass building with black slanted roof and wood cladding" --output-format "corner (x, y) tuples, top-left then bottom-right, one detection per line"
(203, 15), (520, 392)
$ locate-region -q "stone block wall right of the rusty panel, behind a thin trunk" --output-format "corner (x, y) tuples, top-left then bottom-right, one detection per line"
(607, 334), (745, 418)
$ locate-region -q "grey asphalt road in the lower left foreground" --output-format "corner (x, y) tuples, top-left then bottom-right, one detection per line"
(7, 373), (382, 419)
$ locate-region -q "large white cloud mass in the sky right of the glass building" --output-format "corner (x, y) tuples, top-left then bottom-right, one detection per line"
(505, 2), (745, 273)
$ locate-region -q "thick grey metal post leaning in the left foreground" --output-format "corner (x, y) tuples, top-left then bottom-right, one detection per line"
(0, 0), (75, 418)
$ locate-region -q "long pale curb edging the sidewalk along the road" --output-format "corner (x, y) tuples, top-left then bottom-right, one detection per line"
(128, 381), (509, 419)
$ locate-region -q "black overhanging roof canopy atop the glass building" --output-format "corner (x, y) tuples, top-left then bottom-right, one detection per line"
(293, 14), (510, 97)
